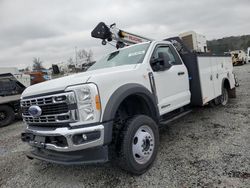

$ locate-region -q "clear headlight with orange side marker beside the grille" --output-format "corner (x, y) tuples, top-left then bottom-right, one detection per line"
(66, 84), (101, 126)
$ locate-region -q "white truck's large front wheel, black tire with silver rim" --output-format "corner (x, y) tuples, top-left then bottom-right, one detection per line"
(117, 115), (159, 175)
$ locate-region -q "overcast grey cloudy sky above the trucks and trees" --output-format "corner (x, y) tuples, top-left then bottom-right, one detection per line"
(0, 0), (250, 68)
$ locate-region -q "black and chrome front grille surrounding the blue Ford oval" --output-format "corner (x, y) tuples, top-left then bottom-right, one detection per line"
(21, 92), (78, 125)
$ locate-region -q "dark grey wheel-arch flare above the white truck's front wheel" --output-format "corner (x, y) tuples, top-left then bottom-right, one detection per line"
(102, 83), (159, 122)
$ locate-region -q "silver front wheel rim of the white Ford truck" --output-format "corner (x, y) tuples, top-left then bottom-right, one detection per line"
(132, 125), (155, 164)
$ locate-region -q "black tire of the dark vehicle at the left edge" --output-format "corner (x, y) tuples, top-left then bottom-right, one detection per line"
(0, 105), (15, 127)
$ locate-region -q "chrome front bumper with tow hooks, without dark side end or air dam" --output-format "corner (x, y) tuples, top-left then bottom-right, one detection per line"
(22, 125), (104, 152)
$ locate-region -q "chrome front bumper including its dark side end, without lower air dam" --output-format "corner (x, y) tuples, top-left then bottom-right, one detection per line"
(21, 121), (113, 152)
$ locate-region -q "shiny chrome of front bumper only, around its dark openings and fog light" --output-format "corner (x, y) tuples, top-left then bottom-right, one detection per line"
(24, 125), (104, 152)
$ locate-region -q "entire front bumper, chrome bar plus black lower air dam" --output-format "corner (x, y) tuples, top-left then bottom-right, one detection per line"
(21, 121), (113, 164)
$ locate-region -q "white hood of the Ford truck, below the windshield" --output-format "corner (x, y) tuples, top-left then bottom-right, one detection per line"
(22, 65), (136, 97)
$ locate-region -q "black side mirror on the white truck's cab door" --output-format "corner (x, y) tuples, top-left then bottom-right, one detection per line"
(150, 52), (172, 71)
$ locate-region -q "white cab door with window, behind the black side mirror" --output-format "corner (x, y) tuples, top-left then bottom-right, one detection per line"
(150, 44), (191, 115)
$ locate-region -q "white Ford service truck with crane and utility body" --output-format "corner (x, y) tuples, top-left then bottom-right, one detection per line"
(21, 22), (235, 174)
